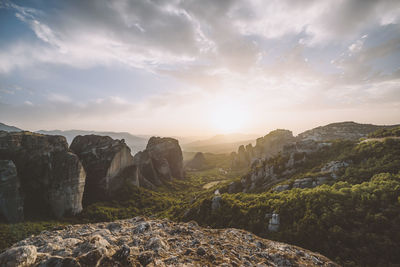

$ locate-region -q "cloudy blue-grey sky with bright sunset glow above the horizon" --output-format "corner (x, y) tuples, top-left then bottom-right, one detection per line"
(0, 0), (400, 136)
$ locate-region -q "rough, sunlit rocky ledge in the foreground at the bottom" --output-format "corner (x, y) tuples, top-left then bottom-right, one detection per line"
(0, 217), (338, 267)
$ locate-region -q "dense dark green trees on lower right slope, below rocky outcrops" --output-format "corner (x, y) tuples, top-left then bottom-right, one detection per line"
(187, 173), (400, 266)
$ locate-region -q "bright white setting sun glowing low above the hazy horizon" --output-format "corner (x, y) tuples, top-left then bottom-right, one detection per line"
(210, 103), (247, 134)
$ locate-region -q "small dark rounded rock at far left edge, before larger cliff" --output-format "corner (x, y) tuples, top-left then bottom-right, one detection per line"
(0, 160), (24, 222)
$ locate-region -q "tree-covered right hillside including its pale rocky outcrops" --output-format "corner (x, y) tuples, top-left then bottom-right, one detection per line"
(185, 131), (400, 266)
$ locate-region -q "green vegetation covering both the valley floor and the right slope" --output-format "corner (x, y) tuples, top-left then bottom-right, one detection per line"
(0, 138), (400, 266)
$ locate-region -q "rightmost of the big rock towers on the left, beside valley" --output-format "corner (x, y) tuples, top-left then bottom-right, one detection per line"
(134, 137), (184, 188)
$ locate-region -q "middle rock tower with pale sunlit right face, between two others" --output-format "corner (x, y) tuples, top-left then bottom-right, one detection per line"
(70, 135), (133, 205)
